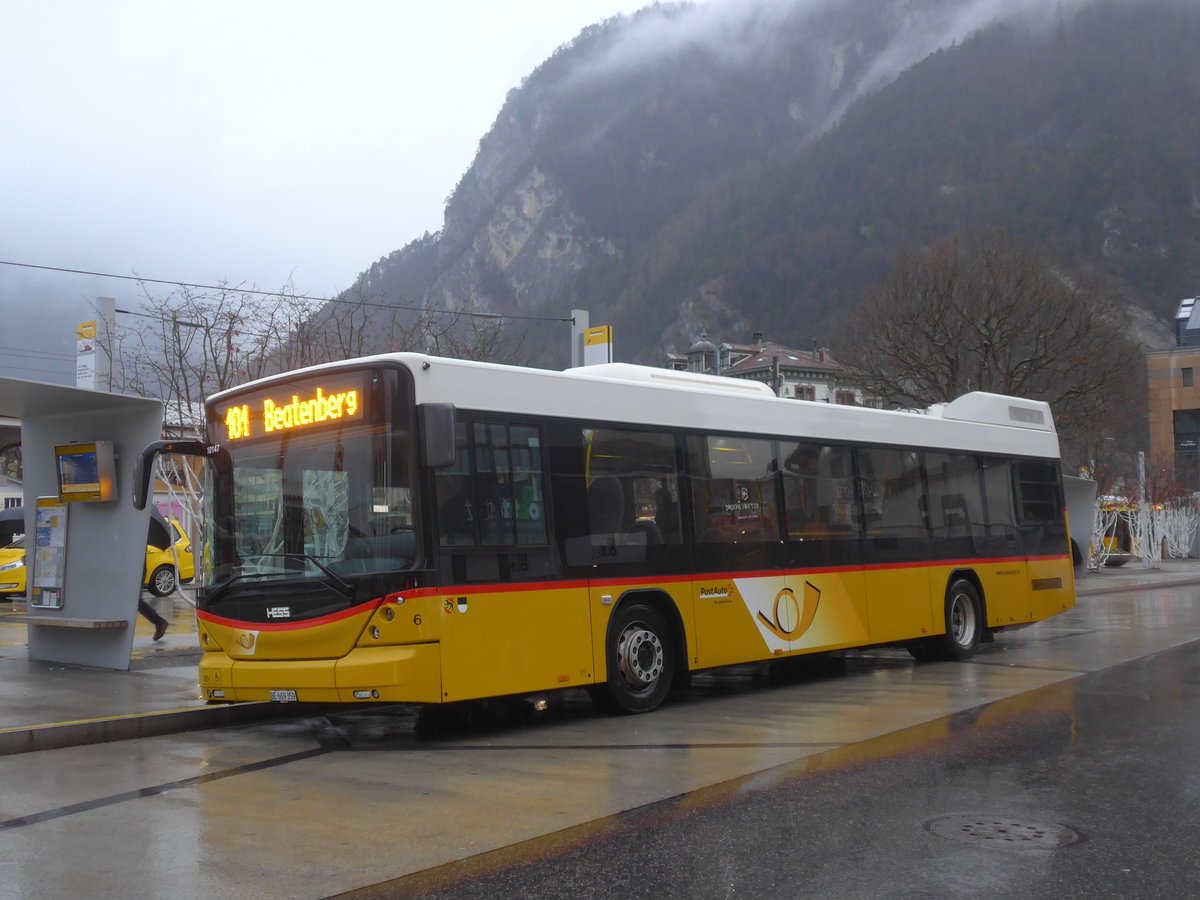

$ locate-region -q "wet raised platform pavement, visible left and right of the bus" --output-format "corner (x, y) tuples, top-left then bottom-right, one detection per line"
(0, 559), (1200, 756)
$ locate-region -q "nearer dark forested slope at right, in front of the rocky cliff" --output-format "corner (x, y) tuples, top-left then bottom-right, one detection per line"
(561, 5), (1200, 360)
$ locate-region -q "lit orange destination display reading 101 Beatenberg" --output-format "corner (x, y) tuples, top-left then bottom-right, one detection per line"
(214, 379), (365, 442)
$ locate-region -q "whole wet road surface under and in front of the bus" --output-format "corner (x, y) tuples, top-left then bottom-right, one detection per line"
(0, 584), (1200, 900)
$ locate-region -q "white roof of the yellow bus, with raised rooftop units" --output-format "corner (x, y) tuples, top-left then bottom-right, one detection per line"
(210, 353), (1058, 457)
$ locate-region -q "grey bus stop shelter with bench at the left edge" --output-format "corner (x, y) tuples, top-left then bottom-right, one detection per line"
(0, 378), (162, 670)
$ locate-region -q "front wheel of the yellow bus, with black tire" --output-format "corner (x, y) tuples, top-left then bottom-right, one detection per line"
(592, 602), (676, 715)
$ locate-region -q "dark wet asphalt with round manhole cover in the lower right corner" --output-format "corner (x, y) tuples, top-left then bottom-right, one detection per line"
(340, 643), (1200, 900)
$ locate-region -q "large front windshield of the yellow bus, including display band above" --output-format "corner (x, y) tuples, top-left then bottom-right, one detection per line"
(202, 367), (416, 601)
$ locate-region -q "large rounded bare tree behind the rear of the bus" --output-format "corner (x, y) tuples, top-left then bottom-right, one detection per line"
(839, 230), (1145, 468)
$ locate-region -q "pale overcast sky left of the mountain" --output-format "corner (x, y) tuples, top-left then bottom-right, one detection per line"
(0, 0), (646, 384)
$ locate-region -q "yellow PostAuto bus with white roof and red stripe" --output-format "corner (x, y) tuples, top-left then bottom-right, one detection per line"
(138, 353), (1074, 713)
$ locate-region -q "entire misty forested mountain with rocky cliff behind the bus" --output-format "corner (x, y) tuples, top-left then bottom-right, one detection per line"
(345, 0), (1200, 366)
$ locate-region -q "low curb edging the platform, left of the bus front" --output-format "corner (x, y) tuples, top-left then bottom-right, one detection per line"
(0, 700), (324, 756)
